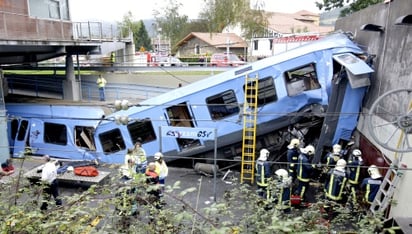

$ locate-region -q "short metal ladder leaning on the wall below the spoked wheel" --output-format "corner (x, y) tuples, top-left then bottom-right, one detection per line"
(370, 159), (403, 214)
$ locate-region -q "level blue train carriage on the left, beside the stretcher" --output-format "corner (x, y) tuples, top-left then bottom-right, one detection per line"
(6, 103), (112, 160)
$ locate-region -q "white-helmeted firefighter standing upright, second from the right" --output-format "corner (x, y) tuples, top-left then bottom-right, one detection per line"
(348, 149), (363, 206)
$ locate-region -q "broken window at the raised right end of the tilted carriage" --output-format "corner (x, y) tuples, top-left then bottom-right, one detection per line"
(285, 63), (320, 96)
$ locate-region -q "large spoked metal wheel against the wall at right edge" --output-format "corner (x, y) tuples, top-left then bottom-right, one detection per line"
(367, 89), (412, 153)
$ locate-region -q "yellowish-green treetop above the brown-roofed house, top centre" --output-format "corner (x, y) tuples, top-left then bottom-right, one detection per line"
(200, 0), (268, 39)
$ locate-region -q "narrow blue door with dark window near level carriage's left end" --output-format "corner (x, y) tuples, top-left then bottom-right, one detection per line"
(10, 119), (30, 157)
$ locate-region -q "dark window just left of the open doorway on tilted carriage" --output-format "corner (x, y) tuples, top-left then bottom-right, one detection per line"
(127, 118), (156, 144)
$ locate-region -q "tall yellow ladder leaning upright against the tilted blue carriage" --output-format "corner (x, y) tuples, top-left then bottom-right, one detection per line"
(240, 75), (259, 184)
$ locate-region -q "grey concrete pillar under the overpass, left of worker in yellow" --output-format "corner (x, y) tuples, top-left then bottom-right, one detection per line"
(63, 54), (81, 101)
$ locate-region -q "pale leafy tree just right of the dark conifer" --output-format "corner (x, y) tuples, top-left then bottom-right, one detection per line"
(153, 0), (188, 53)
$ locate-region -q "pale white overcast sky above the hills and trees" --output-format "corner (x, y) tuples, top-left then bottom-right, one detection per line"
(69, 0), (319, 22)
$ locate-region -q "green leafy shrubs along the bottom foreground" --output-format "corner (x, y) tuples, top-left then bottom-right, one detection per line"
(0, 156), (388, 234)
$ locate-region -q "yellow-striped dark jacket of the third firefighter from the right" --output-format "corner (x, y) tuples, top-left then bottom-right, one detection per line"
(325, 169), (347, 201)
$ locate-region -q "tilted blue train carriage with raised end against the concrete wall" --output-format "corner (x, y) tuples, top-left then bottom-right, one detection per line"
(5, 33), (373, 163)
